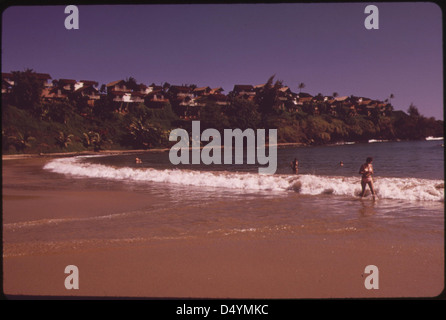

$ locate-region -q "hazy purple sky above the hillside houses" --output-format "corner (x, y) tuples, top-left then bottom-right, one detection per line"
(2, 2), (443, 119)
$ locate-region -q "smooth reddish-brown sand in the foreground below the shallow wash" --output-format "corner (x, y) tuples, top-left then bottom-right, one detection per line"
(4, 234), (443, 299)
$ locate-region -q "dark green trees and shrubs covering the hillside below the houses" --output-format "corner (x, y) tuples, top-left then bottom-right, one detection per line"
(2, 70), (443, 154)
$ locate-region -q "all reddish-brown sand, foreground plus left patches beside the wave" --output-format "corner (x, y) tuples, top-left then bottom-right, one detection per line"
(3, 157), (444, 299)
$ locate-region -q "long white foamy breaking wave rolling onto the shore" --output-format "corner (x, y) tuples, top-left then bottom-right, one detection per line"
(44, 157), (444, 201)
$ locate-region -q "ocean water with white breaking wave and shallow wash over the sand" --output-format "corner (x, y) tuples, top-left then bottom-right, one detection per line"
(4, 141), (444, 255)
